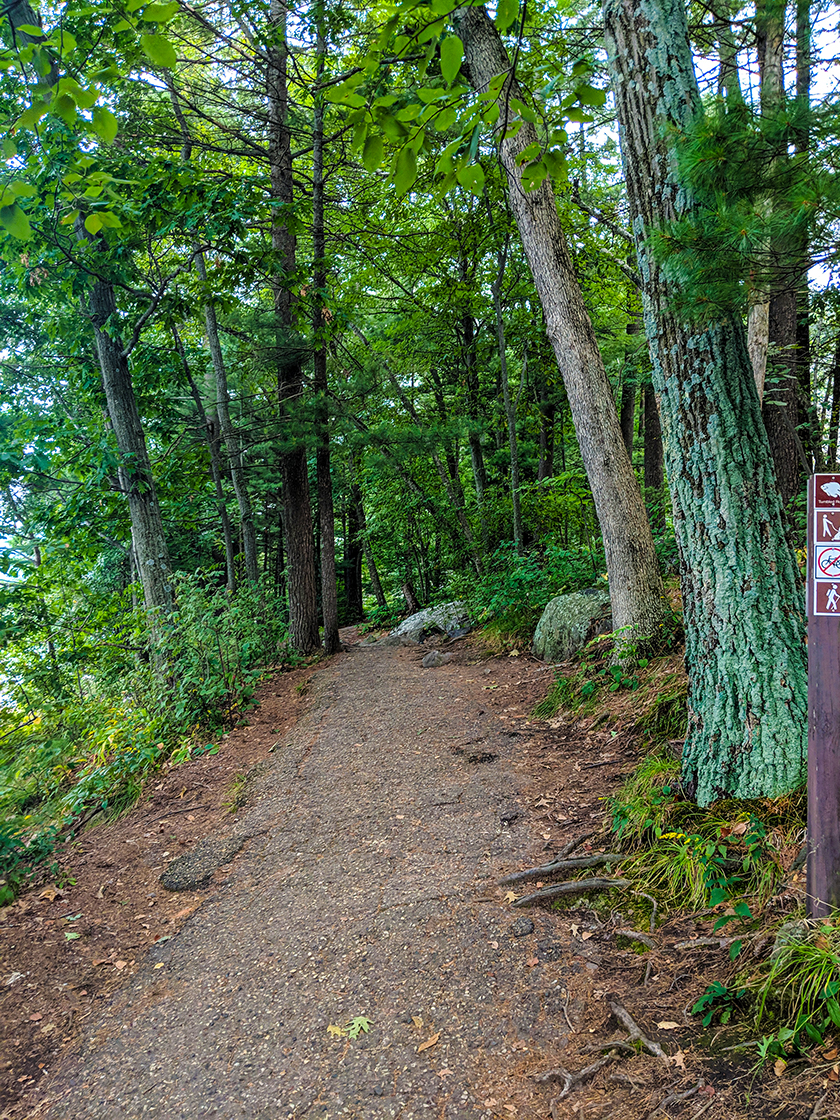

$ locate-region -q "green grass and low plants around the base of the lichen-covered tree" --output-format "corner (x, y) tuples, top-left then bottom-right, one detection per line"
(533, 636), (840, 1082)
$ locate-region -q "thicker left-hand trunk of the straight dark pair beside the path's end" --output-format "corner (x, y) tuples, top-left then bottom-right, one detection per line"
(265, 0), (320, 653)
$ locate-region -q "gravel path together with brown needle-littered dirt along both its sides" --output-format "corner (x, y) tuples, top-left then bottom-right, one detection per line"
(0, 629), (840, 1120)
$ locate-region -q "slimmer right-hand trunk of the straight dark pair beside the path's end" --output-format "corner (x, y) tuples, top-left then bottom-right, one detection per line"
(312, 15), (342, 653)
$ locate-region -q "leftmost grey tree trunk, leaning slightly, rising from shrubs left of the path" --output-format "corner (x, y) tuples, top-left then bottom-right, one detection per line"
(87, 271), (172, 632)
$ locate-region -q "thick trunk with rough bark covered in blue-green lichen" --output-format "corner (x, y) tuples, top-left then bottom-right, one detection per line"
(605, 0), (808, 804)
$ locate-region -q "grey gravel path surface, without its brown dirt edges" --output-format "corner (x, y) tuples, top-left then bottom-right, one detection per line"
(34, 646), (577, 1120)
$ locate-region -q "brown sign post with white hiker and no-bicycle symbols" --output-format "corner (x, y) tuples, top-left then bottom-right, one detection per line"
(808, 474), (840, 917)
